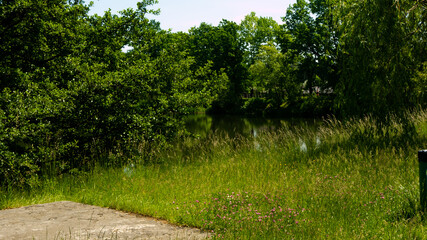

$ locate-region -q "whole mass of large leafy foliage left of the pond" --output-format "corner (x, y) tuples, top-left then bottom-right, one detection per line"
(0, 1), (228, 187)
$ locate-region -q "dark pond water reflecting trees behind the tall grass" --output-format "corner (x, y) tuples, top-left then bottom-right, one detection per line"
(185, 114), (322, 138)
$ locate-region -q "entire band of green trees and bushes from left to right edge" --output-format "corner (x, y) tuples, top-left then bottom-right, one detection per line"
(0, 0), (427, 186)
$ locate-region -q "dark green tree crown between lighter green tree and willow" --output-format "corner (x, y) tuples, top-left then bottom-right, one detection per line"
(279, 0), (338, 93)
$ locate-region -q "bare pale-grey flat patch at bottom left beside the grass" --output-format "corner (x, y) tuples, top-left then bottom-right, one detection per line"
(0, 201), (208, 240)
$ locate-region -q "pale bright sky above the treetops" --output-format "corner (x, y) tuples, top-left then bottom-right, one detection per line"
(87, 0), (296, 32)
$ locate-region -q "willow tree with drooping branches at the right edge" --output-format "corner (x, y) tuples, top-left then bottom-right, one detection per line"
(336, 0), (427, 130)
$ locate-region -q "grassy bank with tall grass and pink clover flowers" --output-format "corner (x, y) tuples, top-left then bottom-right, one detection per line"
(0, 112), (427, 239)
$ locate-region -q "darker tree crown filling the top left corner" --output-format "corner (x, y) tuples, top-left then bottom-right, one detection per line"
(0, 0), (89, 89)
